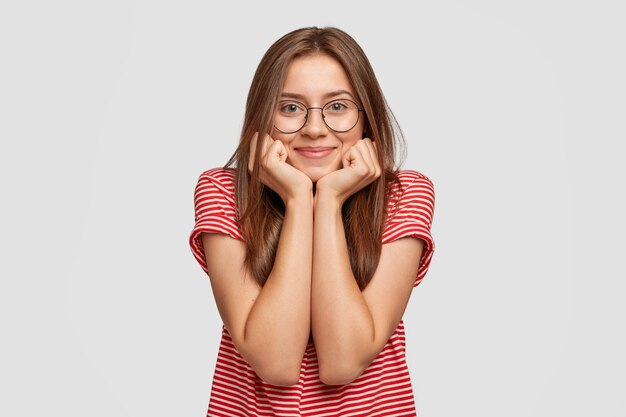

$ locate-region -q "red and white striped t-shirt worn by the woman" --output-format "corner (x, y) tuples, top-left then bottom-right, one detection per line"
(189, 168), (435, 417)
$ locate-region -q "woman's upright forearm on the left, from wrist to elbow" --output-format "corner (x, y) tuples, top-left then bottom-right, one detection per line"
(244, 195), (313, 375)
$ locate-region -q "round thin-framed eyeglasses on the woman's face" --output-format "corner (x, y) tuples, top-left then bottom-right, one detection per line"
(274, 98), (364, 134)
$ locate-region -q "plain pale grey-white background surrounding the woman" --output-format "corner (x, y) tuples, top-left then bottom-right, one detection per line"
(0, 0), (626, 417)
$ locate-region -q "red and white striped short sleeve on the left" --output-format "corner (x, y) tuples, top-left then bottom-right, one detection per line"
(189, 168), (243, 273)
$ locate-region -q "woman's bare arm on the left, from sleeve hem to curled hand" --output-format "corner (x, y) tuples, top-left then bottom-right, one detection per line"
(203, 135), (313, 386)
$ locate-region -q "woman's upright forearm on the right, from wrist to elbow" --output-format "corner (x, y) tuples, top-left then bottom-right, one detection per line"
(311, 195), (375, 379)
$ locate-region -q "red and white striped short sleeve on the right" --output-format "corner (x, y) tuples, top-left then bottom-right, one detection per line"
(383, 171), (435, 287)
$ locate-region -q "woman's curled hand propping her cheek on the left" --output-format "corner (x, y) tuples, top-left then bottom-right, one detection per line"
(248, 133), (313, 204)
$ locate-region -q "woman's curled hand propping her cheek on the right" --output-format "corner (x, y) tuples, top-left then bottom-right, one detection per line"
(316, 138), (382, 205)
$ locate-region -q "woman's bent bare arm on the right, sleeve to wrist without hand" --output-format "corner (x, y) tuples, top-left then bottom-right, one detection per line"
(311, 195), (423, 385)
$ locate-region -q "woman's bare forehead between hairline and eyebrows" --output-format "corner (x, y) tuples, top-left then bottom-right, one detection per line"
(282, 54), (354, 100)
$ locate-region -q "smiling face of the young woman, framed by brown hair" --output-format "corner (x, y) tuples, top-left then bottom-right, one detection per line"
(272, 54), (364, 182)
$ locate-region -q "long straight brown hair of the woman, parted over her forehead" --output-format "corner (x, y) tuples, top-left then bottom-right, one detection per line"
(225, 27), (404, 289)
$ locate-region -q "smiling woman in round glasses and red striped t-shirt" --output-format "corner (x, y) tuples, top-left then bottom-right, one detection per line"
(190, 28), (434, 416)
